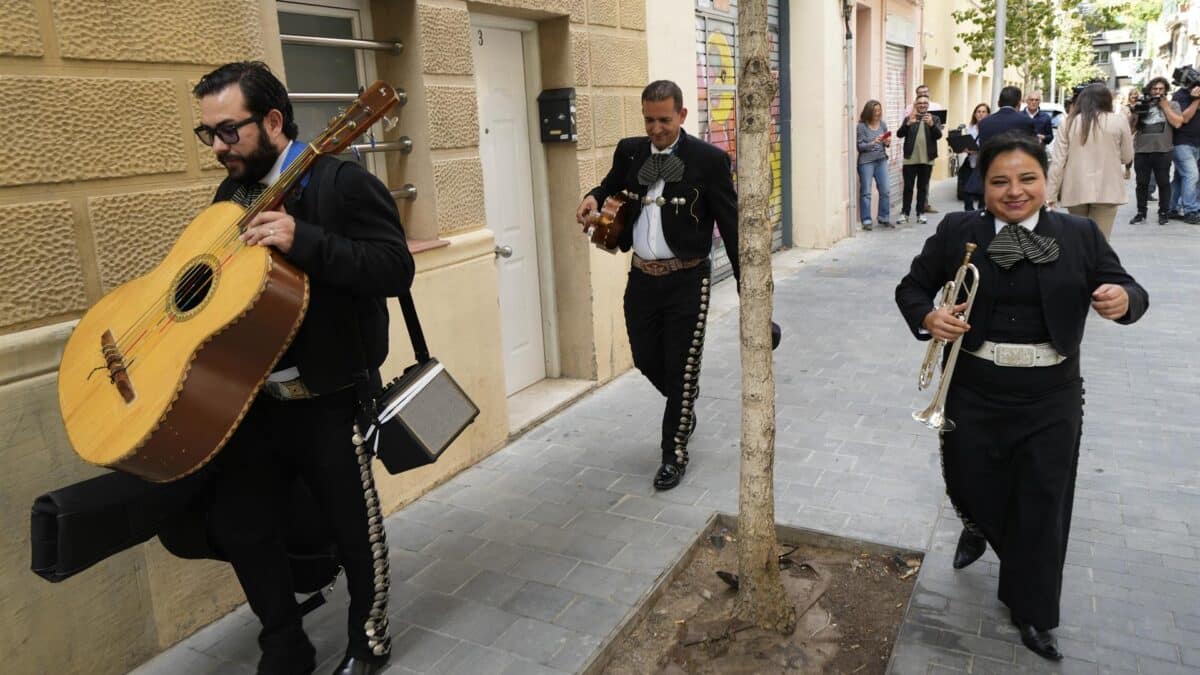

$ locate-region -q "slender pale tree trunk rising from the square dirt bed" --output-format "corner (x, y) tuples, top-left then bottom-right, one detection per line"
(734, 0), (796, 634)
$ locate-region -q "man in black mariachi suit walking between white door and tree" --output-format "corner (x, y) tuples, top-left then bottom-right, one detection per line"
(576, 80), (738, 490)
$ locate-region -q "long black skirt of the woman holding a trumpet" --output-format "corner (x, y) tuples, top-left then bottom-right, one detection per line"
(942, 354), (1082, 631)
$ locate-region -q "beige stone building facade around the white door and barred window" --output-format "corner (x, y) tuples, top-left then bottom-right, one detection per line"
(0, 0), (652, 673)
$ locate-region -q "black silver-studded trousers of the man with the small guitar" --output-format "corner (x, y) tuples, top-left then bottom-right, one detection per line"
(625, 259), (712, 466)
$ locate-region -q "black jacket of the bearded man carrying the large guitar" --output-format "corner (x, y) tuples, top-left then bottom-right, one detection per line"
(214, 156), (415, 394)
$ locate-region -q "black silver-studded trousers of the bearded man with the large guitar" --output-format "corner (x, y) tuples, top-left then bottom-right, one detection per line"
(211, 389), (390, 673)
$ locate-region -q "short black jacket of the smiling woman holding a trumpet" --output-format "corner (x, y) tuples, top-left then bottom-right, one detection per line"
(895, 209), (1150, 357)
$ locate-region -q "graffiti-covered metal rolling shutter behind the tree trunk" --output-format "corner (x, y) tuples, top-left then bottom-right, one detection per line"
(696, 0), (786, 279)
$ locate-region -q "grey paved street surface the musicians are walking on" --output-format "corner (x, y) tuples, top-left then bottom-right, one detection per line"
(136, 183), (1200, 675)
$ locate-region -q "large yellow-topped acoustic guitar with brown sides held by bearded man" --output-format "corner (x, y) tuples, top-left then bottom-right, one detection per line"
(59, 82), (398, 482)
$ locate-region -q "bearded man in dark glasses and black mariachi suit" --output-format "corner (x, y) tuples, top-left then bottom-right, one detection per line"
(193, 62), (414, 675)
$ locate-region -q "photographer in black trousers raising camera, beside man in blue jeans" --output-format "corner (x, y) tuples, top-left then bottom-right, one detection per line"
(1129, 77), (1183, 225)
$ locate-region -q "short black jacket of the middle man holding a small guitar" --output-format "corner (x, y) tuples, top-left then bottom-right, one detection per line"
(589, 129), (740, 279)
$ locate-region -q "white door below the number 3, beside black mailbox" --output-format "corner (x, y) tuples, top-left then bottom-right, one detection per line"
(470, 26), (546, 395)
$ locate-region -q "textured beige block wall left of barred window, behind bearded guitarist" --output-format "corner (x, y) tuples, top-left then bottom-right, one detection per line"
(0, 0), (281, 673)
